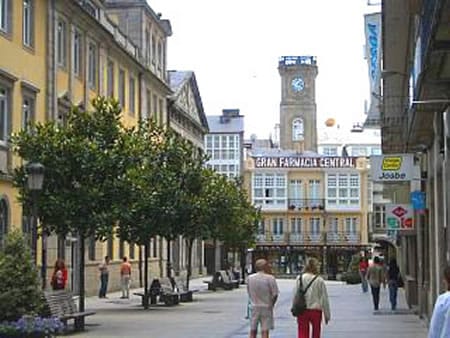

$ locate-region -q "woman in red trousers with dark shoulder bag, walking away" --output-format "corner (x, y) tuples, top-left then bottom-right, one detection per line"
(294, 257), (331, 338)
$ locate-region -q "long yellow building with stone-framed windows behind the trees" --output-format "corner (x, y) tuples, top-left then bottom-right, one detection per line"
(0, 0), (193, 294)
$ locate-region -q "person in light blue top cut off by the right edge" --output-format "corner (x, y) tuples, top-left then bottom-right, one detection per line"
(428, 265), (450, 338)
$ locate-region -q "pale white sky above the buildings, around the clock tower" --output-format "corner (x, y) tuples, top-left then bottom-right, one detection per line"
(147, 0), (379, 138)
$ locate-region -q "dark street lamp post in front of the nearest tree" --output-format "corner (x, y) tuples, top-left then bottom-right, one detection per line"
(26, 162), (45, 284)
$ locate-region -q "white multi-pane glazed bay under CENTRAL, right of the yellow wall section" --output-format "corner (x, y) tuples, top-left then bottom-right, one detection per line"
(327, 174), (360, 208)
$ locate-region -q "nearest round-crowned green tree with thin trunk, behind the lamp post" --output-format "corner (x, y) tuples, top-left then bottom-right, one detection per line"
(12, 97), (130, 325)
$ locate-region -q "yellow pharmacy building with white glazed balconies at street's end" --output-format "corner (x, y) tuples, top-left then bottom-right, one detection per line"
(244, 149), (369, 278)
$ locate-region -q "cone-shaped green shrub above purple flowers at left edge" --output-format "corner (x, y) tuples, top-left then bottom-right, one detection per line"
(0, 231), (44, 322)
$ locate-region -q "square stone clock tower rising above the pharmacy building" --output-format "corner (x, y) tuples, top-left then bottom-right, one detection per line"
(278, 56), (318, 152)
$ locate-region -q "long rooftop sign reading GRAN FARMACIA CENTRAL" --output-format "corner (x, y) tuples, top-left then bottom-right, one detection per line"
(254, 156), (356, 168)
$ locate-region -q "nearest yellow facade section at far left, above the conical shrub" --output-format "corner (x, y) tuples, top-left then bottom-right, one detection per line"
(0, 0), (48, 247)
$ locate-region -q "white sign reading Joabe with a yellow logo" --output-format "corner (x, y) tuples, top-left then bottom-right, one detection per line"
(370, 154), (414, 181)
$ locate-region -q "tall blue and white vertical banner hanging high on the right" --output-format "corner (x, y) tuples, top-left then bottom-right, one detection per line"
(364, 13), (381, 126)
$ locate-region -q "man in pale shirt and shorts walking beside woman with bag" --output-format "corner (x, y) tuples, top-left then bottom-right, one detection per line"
(247, 259), (279, 338)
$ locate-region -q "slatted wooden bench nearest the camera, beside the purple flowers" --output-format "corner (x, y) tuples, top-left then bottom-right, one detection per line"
(44, 290), (95, 331)
